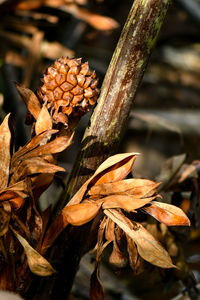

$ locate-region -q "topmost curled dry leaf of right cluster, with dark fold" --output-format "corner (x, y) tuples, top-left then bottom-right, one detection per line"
(68, 153), (137, 205)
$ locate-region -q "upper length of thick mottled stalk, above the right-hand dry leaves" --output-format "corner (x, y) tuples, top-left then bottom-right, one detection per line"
(57, 0), (169, 211)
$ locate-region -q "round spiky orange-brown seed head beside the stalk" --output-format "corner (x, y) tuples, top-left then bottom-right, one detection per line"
(38, 57), (99, 123)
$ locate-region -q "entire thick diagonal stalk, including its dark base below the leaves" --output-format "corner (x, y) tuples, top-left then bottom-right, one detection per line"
(29, 0), (169, 300)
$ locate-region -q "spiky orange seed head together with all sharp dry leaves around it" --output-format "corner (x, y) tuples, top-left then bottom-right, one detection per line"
(0, 58), (190, 299)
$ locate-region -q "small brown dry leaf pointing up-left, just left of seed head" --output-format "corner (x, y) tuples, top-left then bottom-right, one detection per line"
(15, 83), (41, 120)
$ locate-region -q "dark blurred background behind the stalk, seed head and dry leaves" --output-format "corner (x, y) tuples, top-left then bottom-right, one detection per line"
(0, 0), (200, 300)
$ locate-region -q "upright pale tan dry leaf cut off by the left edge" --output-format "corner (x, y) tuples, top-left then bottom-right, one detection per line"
(0, 114), (11, 189)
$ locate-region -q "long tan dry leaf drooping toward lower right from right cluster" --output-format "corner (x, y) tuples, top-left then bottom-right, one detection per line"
(104, 210), (175, 268)
